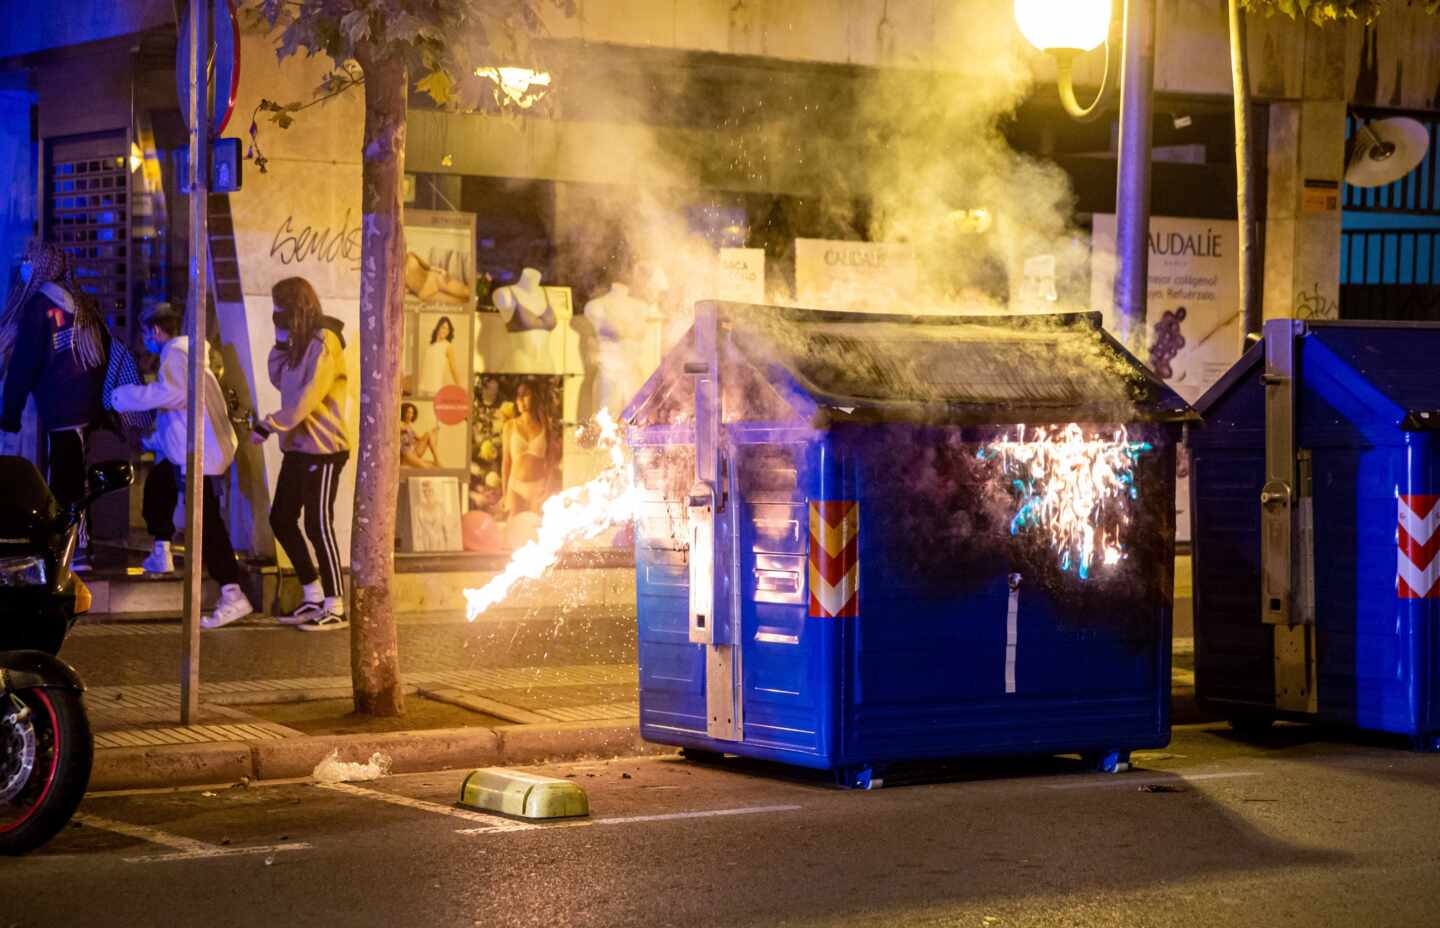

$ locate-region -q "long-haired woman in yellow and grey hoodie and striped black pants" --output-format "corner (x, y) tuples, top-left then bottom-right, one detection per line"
(251, 277), (350, 631)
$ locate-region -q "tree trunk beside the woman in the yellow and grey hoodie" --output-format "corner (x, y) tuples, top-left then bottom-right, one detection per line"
(350, 52), (409, 716)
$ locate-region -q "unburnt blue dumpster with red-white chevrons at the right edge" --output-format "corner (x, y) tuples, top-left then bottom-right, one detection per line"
(1188, 320), (1440, 751)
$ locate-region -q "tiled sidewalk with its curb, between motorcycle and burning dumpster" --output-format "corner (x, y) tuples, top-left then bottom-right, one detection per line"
(70, 605), (647, 790)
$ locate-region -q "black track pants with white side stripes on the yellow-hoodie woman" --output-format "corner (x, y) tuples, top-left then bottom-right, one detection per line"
(271, 451), (350, 597)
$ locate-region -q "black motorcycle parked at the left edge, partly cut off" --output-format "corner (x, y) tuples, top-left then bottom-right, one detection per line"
(0, 455), (134, 855)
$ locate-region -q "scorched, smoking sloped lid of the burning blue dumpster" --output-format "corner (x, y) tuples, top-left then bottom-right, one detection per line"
(625, 303), (1198, 424)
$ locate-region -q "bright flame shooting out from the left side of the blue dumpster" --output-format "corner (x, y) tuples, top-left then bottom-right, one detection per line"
(465, 411), (636, 621)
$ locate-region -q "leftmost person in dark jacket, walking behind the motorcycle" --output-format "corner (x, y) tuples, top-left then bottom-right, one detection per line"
(0, 242), (109, 568)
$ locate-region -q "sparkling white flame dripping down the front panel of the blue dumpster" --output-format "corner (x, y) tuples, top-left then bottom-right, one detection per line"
(979, 422), (1153, 579)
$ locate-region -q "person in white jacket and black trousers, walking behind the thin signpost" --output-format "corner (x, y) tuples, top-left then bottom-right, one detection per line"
(112, 303), (255, 628)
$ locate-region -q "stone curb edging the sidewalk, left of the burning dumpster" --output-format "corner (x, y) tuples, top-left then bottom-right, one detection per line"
(89, 719), (674, 793)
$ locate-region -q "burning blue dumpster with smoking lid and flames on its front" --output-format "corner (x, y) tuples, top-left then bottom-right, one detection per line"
(625, 303), (1194, 785)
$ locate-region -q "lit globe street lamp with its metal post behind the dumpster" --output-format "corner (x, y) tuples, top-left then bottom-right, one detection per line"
(1015, 0), (1155, 352)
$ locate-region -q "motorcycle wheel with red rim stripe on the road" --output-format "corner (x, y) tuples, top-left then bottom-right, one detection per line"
(0, 687), (94, 855)
